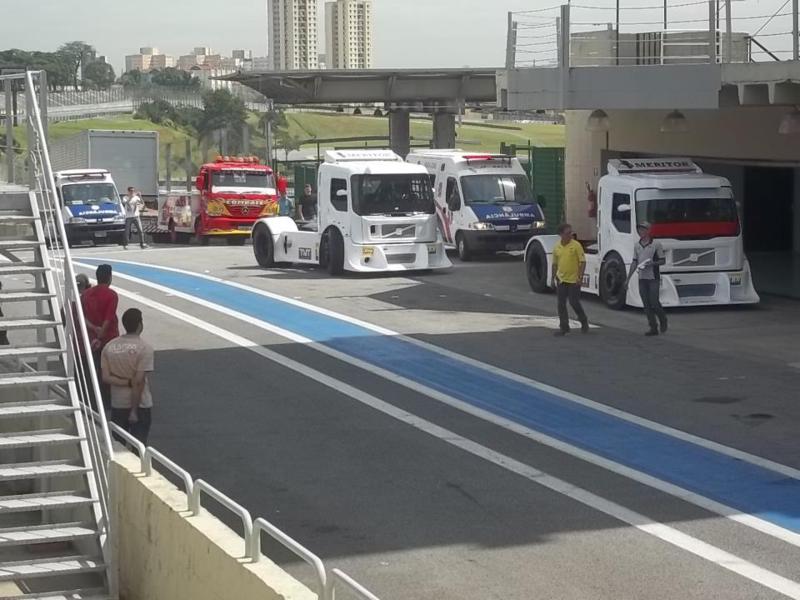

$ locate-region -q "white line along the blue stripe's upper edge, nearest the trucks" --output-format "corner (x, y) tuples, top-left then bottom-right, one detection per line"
(76, 261), (800, 479)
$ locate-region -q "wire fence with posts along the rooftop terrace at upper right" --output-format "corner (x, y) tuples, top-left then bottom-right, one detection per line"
(506, 0), (800, 68)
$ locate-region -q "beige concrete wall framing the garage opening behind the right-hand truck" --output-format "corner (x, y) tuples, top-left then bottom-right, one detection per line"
(565, 107), (800, 239)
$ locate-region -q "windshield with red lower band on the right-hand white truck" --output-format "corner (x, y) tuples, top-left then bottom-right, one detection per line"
(636, 198), (739, 238)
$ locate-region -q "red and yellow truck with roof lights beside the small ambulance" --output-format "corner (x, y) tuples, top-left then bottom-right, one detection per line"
(154, 156), (278, 245)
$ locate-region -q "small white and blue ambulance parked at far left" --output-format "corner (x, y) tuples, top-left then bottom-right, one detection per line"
(55, 169), (125, 245)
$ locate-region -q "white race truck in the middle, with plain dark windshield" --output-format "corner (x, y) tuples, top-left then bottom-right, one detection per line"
(252, 150), (451, 275)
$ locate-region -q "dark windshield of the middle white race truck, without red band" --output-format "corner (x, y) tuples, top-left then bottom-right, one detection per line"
(352, 174), (434, 216)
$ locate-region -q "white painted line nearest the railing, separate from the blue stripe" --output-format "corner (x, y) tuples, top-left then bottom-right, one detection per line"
(109, 288), (800, 600)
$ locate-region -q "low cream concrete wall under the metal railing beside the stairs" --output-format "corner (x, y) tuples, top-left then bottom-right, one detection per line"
(110, 452), (316, 600)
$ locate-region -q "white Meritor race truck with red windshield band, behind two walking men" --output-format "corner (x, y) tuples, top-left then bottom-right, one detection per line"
(525, 158), (759, 309)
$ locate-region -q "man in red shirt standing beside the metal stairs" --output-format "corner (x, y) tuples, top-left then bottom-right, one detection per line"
(81, 265), (119, 407)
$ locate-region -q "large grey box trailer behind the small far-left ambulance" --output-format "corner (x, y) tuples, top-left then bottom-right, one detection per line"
(50, 129), (158, 201)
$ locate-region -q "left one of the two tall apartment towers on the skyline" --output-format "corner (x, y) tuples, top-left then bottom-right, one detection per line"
(267, 0), (319, 71)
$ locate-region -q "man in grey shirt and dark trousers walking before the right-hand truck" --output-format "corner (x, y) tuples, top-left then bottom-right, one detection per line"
(625, 223), (667, 336)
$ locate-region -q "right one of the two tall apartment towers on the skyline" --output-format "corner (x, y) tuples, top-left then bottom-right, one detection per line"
(325, 0), (373, 69)
